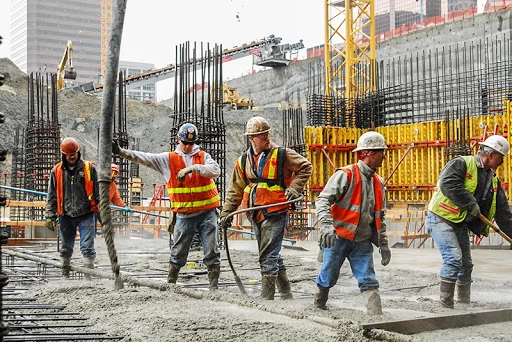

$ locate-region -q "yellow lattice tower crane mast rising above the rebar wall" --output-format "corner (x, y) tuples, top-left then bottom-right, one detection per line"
(324, 0), (377, 99)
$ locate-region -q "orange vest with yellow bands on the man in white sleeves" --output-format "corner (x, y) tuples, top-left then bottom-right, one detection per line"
(167, 151), (220, 213)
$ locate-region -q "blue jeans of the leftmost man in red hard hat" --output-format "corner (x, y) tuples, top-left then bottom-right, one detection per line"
(59, 212), (96, 259)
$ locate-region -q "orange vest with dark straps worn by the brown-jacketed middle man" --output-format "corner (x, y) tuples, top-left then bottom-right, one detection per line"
(237, 148), (291, 214)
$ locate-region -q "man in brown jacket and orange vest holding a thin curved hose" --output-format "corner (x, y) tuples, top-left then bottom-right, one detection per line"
(220, 116), (313, 300)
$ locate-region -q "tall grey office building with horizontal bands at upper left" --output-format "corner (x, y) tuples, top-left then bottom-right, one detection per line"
(10, 0), (101, 84)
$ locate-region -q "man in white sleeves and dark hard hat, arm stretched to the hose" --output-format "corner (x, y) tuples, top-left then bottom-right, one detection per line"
(112, 123), (220, 291)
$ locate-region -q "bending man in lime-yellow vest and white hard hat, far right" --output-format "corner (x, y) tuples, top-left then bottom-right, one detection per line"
(425, 135), (512, 308)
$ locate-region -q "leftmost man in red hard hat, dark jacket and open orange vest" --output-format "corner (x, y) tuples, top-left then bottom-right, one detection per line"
(46, 138), (99, 279)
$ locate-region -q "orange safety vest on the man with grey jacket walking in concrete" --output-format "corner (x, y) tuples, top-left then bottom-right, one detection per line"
(331, 164), (384, 241)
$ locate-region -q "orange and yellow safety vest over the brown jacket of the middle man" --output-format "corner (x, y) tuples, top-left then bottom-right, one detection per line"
(236, 147), (292, 217)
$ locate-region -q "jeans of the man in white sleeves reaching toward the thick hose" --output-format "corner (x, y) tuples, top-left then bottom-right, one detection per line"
(169, 209), (220, 268)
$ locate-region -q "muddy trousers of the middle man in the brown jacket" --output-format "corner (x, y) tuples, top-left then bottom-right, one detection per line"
(251, 213), (288, 274)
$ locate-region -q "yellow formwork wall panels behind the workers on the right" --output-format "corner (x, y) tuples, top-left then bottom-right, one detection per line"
(305, 112), (512, 202)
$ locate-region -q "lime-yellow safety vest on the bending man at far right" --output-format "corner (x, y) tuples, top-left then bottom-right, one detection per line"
(428, 156), (498, 232)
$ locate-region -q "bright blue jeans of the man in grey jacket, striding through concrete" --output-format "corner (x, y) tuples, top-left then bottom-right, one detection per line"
(316, 237), (379, 292)
